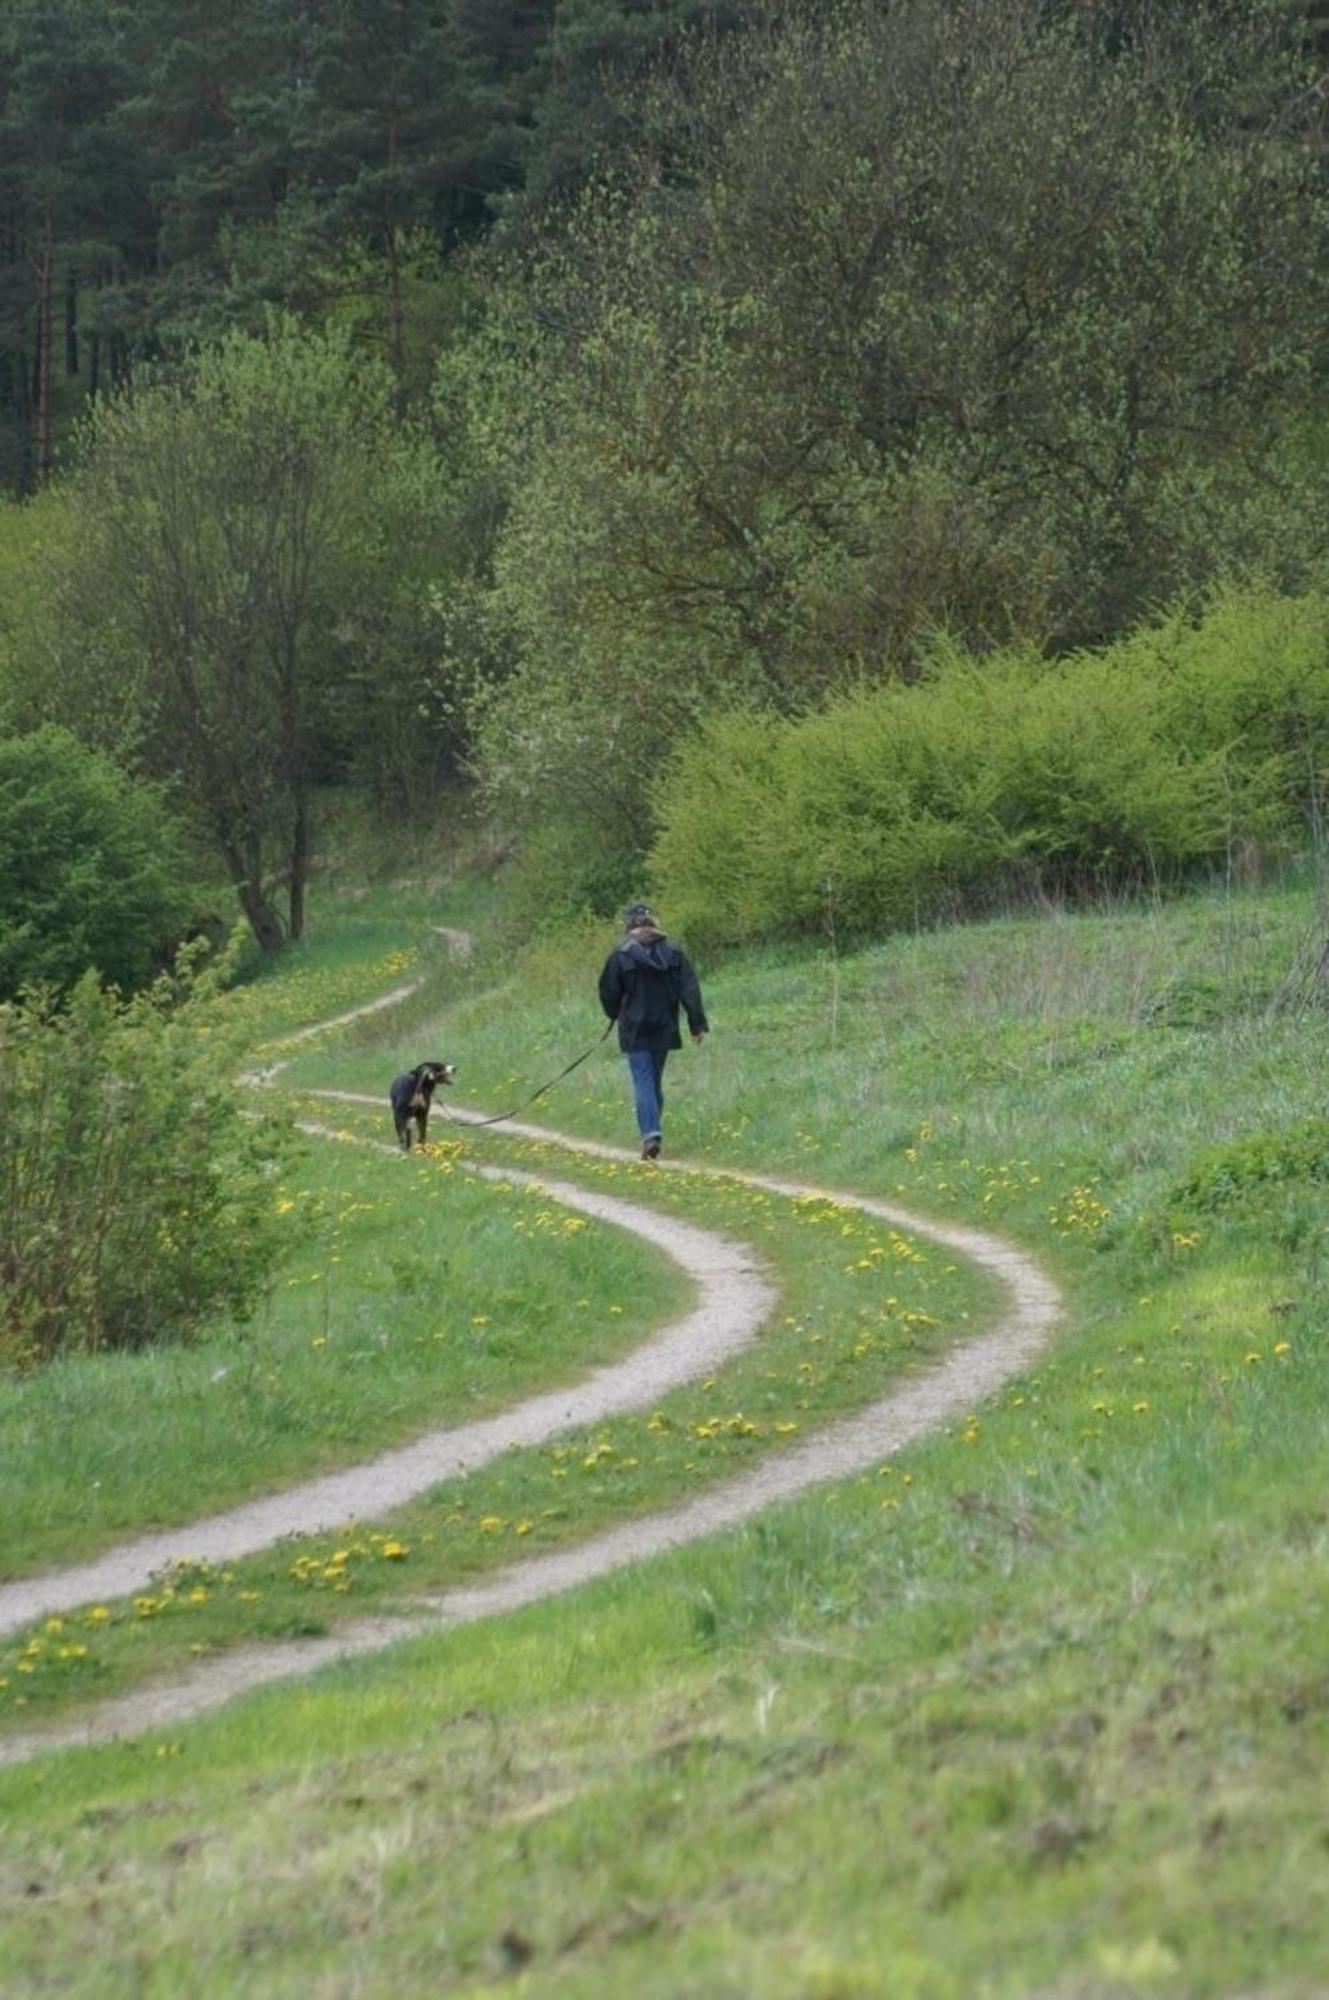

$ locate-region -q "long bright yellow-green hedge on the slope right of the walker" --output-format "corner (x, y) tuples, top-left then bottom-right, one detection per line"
(650, 590), (1329, 940)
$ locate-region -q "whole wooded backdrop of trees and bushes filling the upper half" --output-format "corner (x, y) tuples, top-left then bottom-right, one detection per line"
(0, 0), (1329, 976)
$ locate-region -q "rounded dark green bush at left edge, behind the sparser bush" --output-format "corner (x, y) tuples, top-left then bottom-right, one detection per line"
(0, 724), (188, 994)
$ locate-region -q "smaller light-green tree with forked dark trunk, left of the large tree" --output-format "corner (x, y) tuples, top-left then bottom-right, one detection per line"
(48, 322), (448, 950)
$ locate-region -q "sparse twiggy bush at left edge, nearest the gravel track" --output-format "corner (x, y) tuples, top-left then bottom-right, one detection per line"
(0, 974), (278, 1368)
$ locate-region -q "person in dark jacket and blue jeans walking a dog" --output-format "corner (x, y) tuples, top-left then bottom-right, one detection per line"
(600, 902), (711, 1160)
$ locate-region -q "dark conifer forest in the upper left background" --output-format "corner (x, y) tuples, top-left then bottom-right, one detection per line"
(0, 0), (731, 490)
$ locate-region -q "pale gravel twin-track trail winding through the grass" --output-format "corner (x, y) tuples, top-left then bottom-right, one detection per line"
(0, 964), (1061, 1766)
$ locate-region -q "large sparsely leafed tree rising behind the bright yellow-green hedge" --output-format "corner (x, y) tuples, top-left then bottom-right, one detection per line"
(472, 0), (1329, 838)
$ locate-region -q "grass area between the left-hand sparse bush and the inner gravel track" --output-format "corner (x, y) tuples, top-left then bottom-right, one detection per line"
(0, 1120), (691, 1592)
